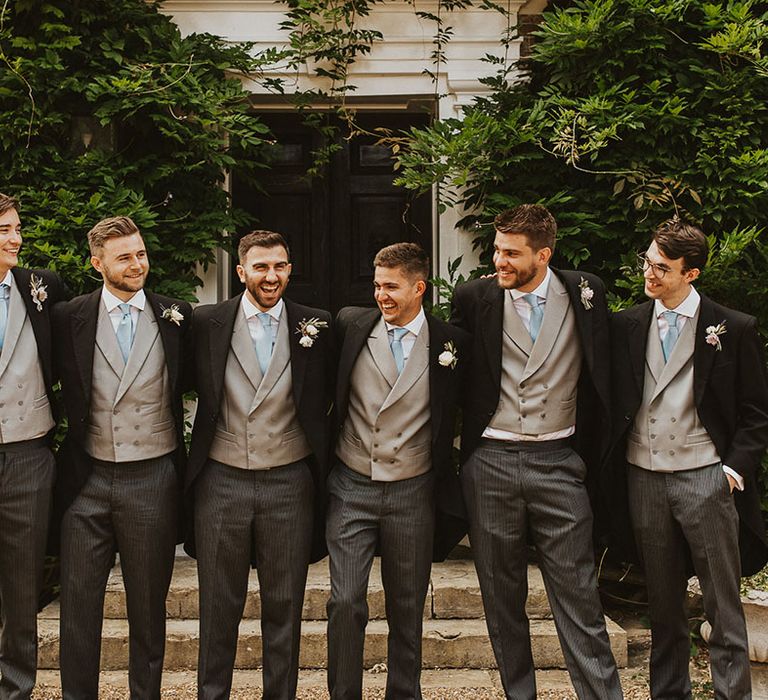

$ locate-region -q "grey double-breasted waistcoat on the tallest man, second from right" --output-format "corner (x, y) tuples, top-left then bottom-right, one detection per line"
(488, 274), (582, 435)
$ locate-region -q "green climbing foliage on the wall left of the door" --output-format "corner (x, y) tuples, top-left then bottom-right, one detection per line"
(0, 0), (274, 299)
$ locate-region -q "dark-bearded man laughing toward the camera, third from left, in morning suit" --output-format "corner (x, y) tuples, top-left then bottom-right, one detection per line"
(187, 231), (335, 700)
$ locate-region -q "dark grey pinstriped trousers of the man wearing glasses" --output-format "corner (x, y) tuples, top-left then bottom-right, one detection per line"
(627, 464), (752, 700)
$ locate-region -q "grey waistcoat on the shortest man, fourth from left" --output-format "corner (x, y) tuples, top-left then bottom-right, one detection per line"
(336, 319), (432, 481)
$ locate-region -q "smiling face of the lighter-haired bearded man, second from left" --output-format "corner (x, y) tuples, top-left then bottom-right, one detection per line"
(91, 233), (149, 301)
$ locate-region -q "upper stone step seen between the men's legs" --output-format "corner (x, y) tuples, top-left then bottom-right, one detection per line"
(37, 557), (551, 620)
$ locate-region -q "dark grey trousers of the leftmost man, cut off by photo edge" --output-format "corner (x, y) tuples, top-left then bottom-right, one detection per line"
(0, 447), (55, 700)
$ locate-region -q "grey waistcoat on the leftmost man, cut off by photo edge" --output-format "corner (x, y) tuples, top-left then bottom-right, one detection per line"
(0, 284), (54, 444)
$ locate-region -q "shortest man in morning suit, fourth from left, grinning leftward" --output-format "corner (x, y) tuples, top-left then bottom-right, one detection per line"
(326, 243), (469, 700)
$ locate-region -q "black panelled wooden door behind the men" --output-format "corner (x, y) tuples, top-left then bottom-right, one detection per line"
(232, 113), (432, 313)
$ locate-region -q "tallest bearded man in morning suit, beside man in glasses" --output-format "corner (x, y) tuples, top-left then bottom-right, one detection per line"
(451, 204), (621, 700)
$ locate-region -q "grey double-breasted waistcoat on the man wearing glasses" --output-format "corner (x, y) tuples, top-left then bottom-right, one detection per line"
(627, 311), (720, 472)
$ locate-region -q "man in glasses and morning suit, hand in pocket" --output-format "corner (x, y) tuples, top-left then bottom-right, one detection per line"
(612, 218), (768, 700)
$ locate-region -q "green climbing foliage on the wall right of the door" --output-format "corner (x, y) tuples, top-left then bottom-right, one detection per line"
(400, 0), (768, 320)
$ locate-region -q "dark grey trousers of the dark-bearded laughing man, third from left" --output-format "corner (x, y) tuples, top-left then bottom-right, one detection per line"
(195, 460), (314, 700)
